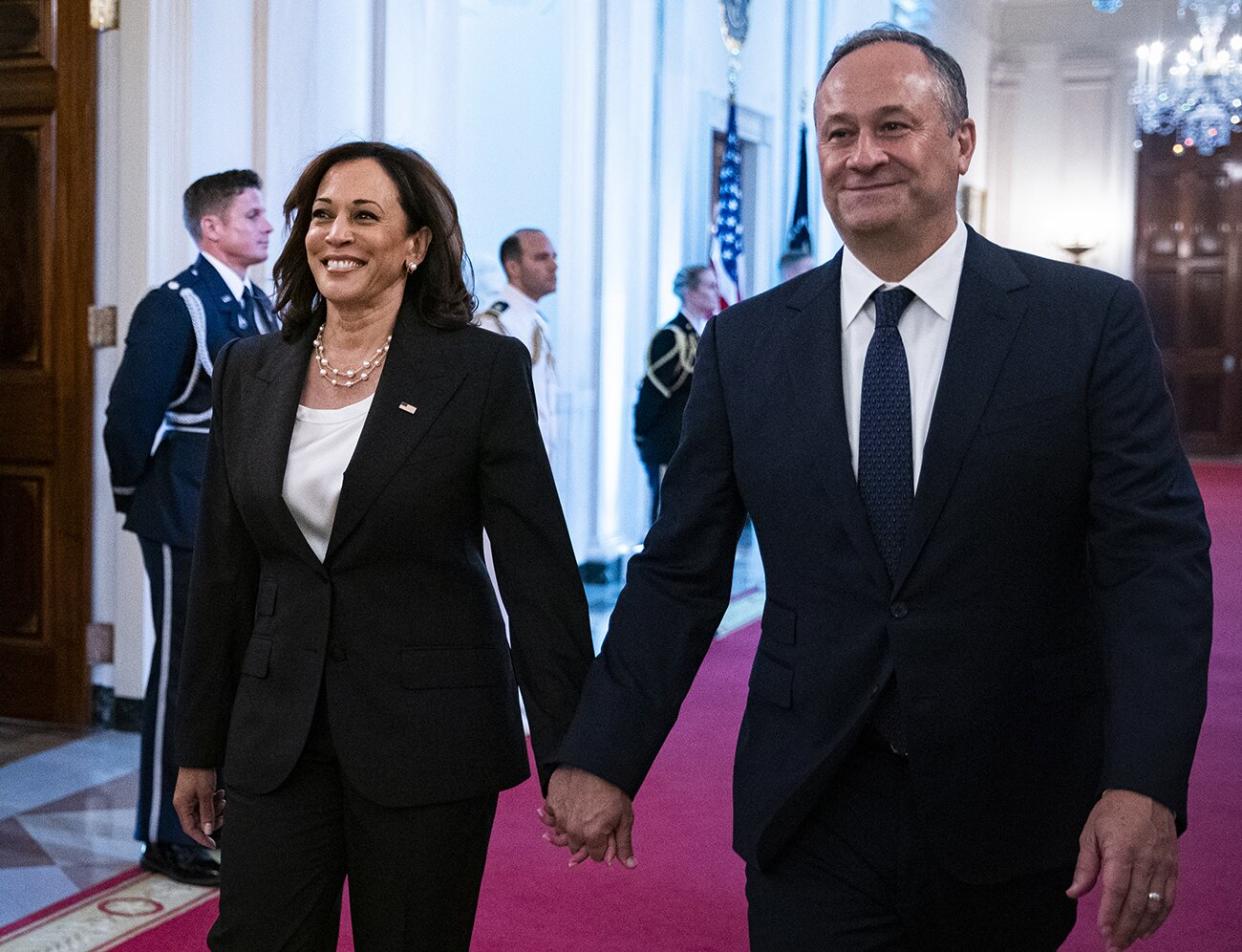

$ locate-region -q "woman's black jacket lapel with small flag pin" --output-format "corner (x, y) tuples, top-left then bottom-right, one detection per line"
(324, 308), (466, 562)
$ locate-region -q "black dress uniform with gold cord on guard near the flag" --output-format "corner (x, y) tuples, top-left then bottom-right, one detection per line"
(633, 314), (698, 523)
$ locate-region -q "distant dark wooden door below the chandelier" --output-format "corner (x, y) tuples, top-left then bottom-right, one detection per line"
(1135, 137), (1242, 454)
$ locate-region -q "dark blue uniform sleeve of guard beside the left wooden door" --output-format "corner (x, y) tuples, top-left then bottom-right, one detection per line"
(103, 288), (195, 513)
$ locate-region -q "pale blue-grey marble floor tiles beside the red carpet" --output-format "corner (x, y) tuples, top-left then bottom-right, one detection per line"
(0, 541), (764, 928)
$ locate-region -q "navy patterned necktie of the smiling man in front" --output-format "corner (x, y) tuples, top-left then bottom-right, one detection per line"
(858, 285), (914, 580)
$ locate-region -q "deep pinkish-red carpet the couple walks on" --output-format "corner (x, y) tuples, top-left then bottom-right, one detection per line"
(55, 464), (1242, 952)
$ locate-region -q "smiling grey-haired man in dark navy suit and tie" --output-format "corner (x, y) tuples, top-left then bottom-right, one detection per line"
(545, 27), (1212, 952)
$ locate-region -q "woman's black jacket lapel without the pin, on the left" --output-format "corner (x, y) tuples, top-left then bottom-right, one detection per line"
(246, 330), (319, 565)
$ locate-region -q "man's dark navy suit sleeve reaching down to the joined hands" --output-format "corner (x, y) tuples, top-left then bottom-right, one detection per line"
(563, 320), (745, 796)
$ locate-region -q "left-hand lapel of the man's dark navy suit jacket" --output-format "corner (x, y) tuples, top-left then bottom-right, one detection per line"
(785, 252), (889, 590)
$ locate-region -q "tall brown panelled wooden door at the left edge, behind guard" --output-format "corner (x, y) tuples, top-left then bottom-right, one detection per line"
(0, 0), (97, 724)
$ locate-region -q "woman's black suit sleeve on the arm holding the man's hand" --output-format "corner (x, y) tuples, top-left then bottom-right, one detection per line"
(481, 338), (594, 791)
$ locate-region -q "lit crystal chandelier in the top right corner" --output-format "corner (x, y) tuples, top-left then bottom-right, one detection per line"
(1130, 0), (1242, 155)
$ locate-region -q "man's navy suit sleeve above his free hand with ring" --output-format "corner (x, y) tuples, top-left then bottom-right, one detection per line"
(1088, 282), (1212, 827)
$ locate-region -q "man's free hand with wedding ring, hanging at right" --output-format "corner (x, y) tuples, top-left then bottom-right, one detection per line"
(1066, 789), (1177, 952)
